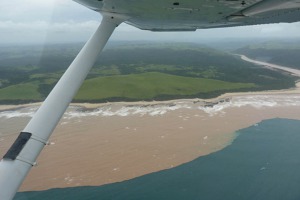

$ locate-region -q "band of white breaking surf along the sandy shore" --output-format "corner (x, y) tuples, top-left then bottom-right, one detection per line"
(0, 94), (300, 119)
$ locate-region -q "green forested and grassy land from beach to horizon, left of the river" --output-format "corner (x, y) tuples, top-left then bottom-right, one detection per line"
(0, 42), (295, 103)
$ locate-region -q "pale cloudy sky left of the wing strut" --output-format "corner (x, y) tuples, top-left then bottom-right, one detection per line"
(0, 0), (101, 44)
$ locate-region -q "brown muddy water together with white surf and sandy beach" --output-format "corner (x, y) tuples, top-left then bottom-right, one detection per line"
(0, 57), (300, 191)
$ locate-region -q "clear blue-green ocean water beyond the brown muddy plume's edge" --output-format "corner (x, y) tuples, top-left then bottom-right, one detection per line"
(14, 119), (300, 200)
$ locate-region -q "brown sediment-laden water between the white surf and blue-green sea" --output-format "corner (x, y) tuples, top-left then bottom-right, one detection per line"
(0, 96), (300, 191)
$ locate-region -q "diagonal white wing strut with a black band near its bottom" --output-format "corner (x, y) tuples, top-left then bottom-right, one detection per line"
(0, 14), (125, 200)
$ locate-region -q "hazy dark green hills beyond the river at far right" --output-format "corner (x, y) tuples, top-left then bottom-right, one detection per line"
(235, 41), (300, 69)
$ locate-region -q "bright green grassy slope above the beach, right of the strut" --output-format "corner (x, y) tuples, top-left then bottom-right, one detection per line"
(75, 72), (255, 101)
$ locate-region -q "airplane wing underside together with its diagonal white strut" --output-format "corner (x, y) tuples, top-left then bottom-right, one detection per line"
(0, 0), (300, 200)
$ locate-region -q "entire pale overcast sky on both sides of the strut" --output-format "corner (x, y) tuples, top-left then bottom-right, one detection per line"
(0, 0), (300, 44)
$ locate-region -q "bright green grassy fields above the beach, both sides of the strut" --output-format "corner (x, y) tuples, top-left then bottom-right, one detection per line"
(0, 72), (257, 103)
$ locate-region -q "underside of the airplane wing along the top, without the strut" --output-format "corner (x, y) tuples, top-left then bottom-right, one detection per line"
(74, 0), (300, 31)
